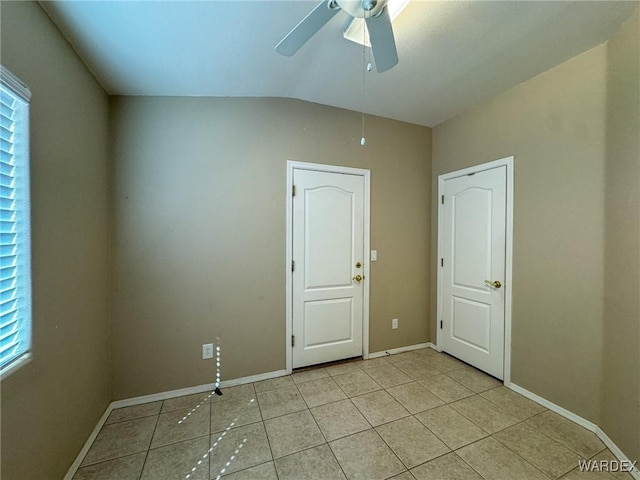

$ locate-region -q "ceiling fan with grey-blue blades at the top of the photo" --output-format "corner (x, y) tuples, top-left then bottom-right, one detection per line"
(276, 0), (398, 72)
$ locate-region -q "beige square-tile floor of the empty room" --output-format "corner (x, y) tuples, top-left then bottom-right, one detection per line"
(73, 349), (632, 480)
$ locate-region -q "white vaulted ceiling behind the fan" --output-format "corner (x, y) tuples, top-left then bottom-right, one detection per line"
(41, 0), (640, 127)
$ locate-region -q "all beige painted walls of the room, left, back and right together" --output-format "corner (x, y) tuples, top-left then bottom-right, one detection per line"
(0, 1), (640, 472)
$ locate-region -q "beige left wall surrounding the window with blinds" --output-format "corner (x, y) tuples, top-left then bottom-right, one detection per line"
(0, 1), (111, 480)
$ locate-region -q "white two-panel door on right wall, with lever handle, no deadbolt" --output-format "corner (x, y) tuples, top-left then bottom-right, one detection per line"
(439, 166), (507, 379)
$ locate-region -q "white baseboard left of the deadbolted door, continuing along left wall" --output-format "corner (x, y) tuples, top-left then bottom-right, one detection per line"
(63, 370), (287, 480)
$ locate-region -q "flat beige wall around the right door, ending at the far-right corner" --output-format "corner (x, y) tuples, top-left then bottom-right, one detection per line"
(431, 45), (607, 422)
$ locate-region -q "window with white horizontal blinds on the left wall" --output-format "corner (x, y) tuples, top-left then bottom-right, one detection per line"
(0, 66), (31, 377)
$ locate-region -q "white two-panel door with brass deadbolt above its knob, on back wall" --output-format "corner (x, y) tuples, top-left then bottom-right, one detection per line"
(292, 169), (367, 368)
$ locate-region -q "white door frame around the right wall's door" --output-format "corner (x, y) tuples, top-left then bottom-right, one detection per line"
(436, 157), (513, 387)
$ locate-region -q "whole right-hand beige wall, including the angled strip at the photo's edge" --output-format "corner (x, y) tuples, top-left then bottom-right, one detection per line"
(430, 10), (640, 460)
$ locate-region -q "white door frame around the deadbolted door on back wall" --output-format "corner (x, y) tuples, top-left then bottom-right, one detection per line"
(285, 160), (371, 373)
